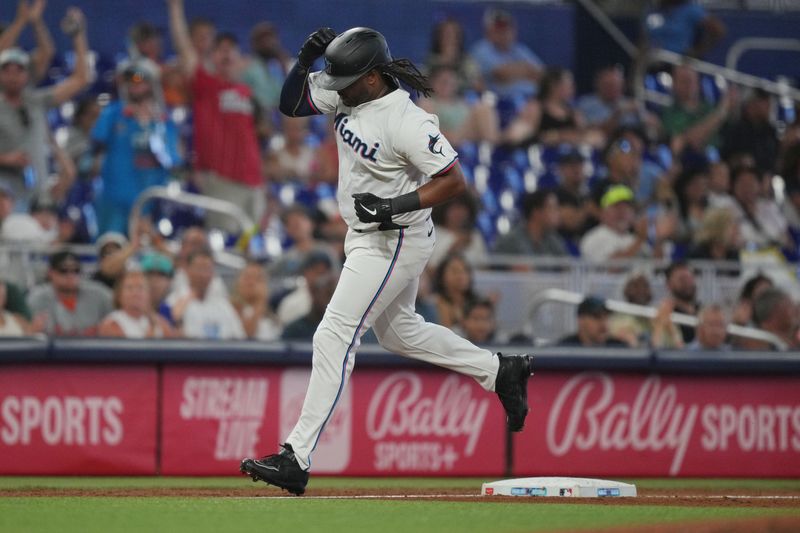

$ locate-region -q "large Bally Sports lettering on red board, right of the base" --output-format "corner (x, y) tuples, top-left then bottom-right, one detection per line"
(546, 372), (800, 476)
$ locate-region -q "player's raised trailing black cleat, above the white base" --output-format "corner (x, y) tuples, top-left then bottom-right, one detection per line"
(494, 353), (533, 431)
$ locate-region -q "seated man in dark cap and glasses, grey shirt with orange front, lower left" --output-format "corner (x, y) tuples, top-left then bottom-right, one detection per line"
(28, 250), (113, 336)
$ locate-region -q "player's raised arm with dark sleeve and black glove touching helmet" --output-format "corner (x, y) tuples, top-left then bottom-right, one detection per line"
(279, 28), (336, 117)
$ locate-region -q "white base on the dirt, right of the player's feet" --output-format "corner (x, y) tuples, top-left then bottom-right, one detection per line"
(481, 477), (636, 498)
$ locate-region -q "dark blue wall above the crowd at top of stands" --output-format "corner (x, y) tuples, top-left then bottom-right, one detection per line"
(0, 0), (574, 67)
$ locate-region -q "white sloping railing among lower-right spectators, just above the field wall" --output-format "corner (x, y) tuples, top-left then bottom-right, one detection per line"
(528, 289), (787, 350)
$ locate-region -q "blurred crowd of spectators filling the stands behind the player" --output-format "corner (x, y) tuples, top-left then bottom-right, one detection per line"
(0, 0), (800, 349)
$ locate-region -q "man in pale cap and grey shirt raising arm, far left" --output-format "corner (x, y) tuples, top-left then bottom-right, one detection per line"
(0, 8), (89, 211)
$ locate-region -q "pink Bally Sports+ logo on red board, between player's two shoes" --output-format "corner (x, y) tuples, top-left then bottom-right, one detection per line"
(366, 372), (490, 472)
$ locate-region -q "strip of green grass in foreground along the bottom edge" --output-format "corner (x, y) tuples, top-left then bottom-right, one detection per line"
(0, 498), (786, 533)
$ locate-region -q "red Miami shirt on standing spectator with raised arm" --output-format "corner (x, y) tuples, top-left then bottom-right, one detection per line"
(192, 66), (263, 187)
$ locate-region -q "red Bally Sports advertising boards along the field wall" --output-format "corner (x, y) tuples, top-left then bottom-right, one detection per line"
(0, 365), (800, 477)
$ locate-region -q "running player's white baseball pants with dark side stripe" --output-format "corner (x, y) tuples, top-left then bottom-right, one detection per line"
(286, 220), (499, 469)
